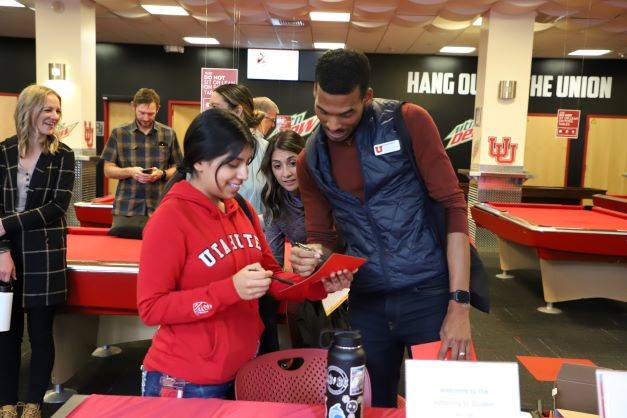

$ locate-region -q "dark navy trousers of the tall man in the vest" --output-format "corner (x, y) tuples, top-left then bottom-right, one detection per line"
(348, 286), (449, 408)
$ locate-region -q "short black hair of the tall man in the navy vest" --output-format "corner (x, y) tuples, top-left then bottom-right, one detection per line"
(316, 49), (370, 97)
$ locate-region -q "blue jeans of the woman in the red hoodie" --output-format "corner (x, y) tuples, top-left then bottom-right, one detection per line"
(142, 371), (233, 399)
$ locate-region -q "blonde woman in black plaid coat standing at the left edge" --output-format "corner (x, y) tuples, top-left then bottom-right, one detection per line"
(0, 85), (74, 417)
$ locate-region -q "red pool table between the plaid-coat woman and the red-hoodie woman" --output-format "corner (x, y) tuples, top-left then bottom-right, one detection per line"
(52, 228), (156, 384)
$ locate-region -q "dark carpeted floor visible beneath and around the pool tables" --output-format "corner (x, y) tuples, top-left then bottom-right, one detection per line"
(21, 250), (627, 416)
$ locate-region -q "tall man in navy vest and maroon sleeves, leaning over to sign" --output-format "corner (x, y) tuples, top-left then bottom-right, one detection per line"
(291, 49), (471, 407)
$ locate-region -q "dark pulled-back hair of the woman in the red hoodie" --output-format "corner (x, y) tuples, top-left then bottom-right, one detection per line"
(161, 109), (257, 198)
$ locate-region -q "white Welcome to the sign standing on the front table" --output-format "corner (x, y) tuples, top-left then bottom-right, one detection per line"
(405, 360), (521, 418)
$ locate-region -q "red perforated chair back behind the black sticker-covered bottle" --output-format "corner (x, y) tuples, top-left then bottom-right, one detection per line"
(235, 348), (372, 406)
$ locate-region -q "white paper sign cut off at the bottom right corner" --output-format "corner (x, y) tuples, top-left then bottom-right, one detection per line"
(596, 370), (627, 418)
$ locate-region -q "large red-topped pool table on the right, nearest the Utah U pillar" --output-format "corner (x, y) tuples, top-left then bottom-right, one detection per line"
(471, 203), (627, 313)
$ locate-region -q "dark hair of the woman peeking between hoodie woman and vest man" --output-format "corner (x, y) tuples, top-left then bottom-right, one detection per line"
(259, 131), (305, 219)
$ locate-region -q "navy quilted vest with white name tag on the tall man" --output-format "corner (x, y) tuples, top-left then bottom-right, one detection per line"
(306, 99), (448, 293)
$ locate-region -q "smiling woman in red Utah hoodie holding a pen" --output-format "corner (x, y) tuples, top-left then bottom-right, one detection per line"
(137, 109), (352, 398)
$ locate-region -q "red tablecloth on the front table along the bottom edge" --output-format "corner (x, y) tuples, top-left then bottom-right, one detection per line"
(68, 395), (405, 418)
